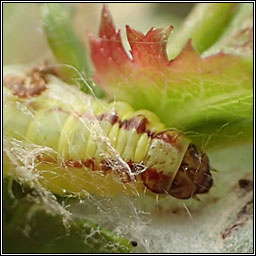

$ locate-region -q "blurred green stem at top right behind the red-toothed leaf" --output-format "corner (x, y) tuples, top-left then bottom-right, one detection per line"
(167, 3), (238, 59)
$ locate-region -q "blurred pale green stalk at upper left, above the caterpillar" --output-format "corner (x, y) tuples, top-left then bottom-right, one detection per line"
(41, 3), (103, 97)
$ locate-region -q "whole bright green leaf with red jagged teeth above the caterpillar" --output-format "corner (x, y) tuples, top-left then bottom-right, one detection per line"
(90, 4), (253, 149)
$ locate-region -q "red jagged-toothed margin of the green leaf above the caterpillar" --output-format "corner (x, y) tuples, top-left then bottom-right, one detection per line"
(88, 4), (218, 86)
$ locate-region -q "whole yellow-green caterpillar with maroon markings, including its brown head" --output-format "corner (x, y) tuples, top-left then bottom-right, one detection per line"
(3, 67), (213, 199)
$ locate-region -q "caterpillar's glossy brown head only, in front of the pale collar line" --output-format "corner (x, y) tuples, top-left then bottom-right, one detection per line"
(168, 143), (213, 199)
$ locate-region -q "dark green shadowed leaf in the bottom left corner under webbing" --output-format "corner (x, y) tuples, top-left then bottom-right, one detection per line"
(3, 179), (132, 253)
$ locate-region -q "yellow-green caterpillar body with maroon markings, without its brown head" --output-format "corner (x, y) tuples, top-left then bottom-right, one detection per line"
(4, 66), (212, 198)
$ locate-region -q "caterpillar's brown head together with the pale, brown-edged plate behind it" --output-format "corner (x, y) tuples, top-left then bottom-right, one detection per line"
(141, 129), (213, 199)
